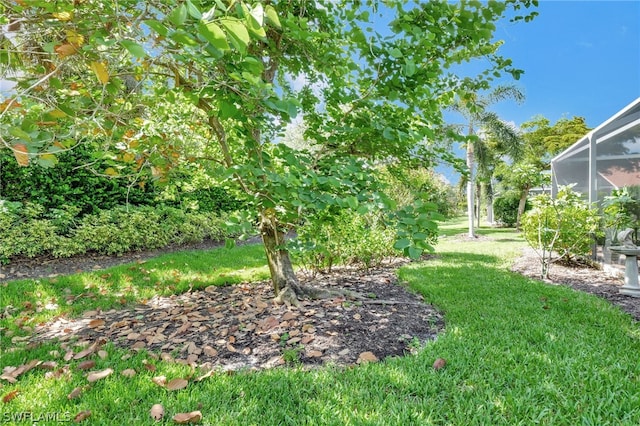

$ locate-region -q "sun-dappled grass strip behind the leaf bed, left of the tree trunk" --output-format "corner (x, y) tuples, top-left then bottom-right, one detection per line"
(0, 245), (269, 343)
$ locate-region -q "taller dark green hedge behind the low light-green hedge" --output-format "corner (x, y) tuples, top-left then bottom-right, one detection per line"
(0, 144), (242, 216)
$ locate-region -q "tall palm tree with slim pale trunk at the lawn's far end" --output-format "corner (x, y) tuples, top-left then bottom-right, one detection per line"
(454, 85), (524, 237)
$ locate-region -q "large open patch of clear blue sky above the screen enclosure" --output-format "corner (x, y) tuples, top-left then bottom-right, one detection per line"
(492, 0), (640, 127)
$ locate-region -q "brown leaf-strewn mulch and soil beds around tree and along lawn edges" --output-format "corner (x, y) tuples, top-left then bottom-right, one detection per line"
(0, 238), (640, 370)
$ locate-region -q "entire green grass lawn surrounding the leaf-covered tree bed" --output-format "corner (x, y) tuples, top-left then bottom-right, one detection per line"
(0, 218), (640, 425)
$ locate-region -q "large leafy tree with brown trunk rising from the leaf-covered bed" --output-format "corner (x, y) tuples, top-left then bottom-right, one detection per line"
(0, 0), (537, 303)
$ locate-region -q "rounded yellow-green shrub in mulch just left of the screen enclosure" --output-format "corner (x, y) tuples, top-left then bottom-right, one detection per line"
(522, 186), (599, 278)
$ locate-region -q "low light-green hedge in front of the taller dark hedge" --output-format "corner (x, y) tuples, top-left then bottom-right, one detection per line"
(0, 201), (228, 263)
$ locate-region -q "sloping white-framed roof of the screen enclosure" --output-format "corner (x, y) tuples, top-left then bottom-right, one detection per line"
(551, 98), (640, 162)
